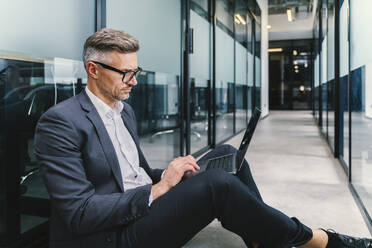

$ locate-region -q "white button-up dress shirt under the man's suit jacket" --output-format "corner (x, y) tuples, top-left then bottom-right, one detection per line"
(85, 87), (153, 202)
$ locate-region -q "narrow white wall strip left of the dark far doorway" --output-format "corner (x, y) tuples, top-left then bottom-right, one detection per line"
(257, 0), (269, 117)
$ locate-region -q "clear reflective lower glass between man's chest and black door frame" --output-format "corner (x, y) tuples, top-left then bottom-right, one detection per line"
(127, 71), (181, 169)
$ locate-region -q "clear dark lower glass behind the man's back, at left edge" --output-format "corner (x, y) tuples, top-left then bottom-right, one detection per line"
(0, 55), (86, 244)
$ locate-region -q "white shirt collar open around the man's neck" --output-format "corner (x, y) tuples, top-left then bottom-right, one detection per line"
(85, 87), (124, 120)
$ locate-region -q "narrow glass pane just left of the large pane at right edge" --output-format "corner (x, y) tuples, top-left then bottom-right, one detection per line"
(340, 1), (349, 166)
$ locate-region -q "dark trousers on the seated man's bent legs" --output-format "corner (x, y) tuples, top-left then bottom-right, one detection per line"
(125, 145), (312, 248)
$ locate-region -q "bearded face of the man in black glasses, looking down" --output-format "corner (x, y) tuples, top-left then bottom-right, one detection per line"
(97, 51), (138, 101)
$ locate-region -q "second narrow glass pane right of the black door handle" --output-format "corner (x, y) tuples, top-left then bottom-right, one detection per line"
(216, 0), (234, 143)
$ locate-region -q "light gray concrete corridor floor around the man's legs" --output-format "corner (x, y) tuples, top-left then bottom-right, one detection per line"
(184, 111), (371, 248)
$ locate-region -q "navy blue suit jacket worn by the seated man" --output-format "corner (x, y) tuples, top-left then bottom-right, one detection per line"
(35, 91), (162, 248)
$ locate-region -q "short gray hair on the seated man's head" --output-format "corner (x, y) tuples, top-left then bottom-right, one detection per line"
(83, 28), (139, 69)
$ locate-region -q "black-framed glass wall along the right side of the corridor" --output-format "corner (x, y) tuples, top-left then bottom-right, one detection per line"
(314, 0), (372, 228)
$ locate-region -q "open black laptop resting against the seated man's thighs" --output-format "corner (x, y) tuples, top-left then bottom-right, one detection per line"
(199, 108), (261, 173)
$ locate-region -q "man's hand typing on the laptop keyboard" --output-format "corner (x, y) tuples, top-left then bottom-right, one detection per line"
(151, 155), (200, 200)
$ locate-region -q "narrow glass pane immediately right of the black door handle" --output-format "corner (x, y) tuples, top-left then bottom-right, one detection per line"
(190, 1), (211, 153)
